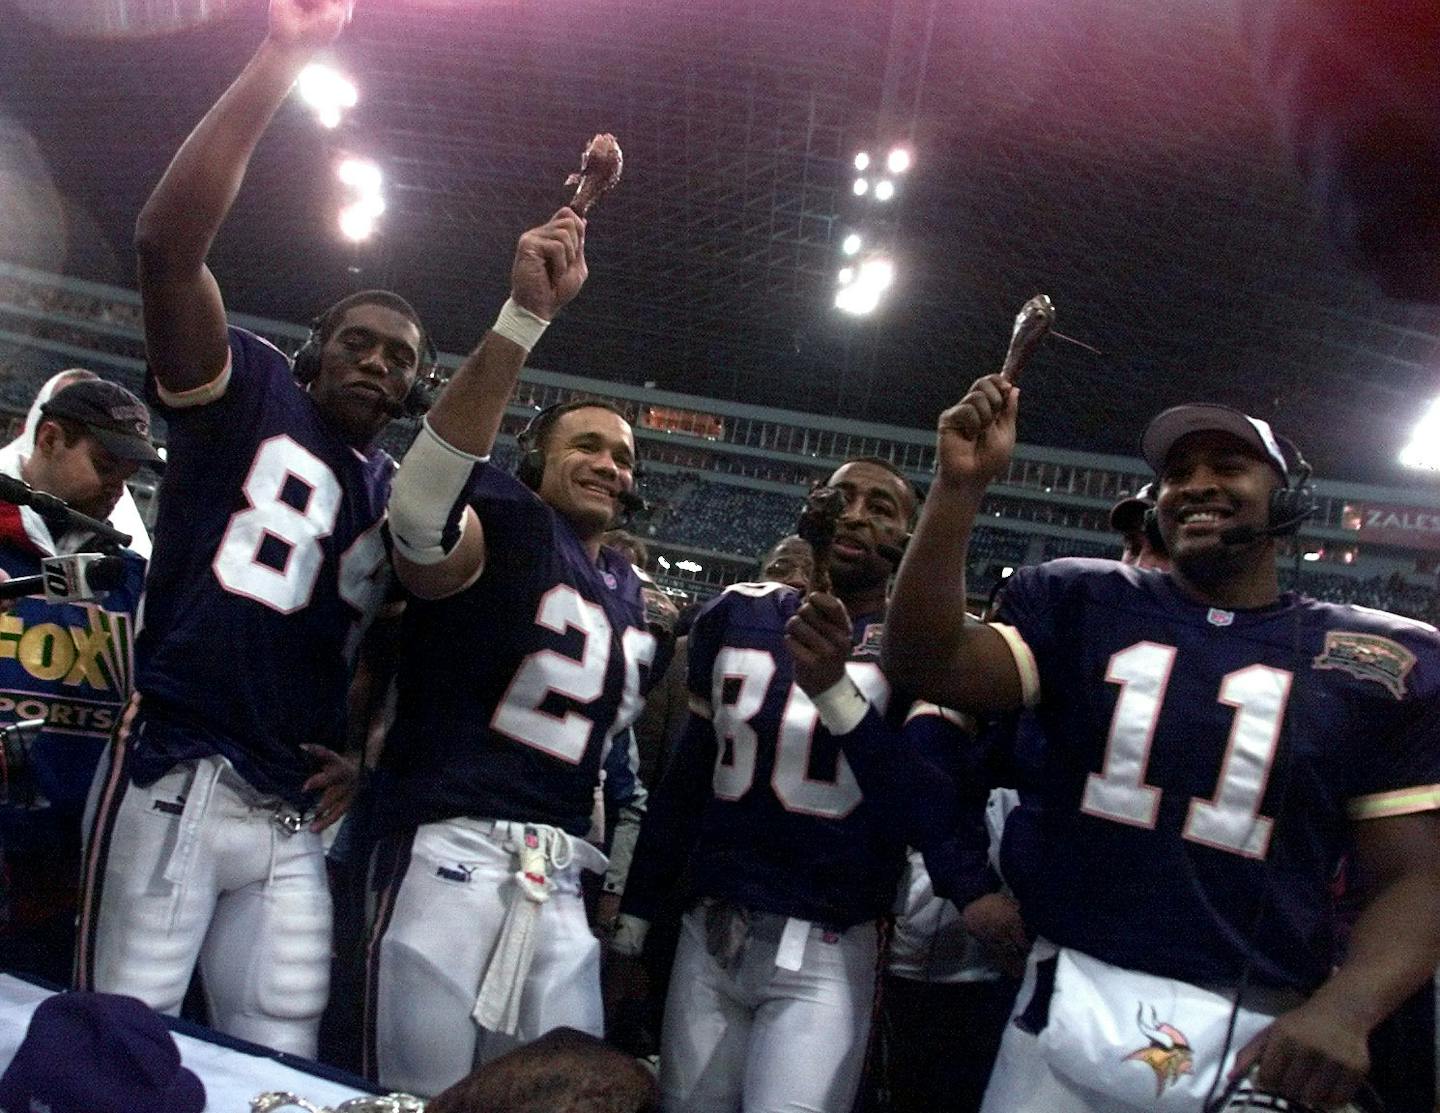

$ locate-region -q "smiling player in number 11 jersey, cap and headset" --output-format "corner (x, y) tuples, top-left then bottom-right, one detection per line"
(884, 376), (1440, 1113)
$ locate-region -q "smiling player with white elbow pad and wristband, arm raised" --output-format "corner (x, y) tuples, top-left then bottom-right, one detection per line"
(366, 209), (655, 1094)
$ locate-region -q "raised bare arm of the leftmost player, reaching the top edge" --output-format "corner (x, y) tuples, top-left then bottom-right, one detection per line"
(135, 0), (354, 395)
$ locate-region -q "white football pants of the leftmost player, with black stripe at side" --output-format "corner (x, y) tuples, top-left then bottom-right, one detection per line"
(76, 743), (331, 1058)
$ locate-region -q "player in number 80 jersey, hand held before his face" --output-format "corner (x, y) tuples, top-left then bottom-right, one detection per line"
(613, 459), (962, 1113)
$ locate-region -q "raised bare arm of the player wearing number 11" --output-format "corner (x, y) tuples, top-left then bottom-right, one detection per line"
(884, 374), (1024, 711)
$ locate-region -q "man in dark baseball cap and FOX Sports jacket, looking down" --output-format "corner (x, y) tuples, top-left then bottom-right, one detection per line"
(0, 379), (150, 982)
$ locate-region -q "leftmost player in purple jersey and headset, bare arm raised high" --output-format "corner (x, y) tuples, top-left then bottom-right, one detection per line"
(76, 0), (426, 1055)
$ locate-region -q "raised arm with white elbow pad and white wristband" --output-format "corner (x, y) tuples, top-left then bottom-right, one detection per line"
(390, 209), (589, 599)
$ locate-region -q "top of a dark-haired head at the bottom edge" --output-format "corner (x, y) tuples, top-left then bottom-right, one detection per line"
(425, 1028), (660, 1113)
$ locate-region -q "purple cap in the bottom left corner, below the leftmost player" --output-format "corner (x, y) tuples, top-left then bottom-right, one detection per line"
(0, 992), (204, 1113)
